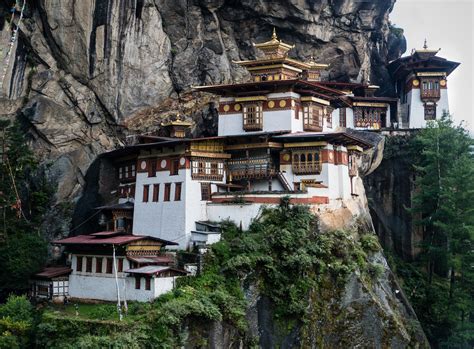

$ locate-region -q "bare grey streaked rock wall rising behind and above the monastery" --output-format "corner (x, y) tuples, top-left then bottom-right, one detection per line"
(0, 0), (404, 209)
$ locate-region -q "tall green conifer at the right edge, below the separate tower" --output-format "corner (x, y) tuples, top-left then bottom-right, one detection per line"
(411, 115), (474, 347)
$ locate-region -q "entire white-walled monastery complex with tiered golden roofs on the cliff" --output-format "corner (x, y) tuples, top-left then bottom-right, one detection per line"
(27, 32), (458, 301)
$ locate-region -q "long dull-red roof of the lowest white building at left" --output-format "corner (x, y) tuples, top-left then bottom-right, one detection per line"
(53, 233), (178, 246)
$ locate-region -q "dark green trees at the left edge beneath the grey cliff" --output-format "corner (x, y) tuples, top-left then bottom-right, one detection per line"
(0, 121), (53, 299)
